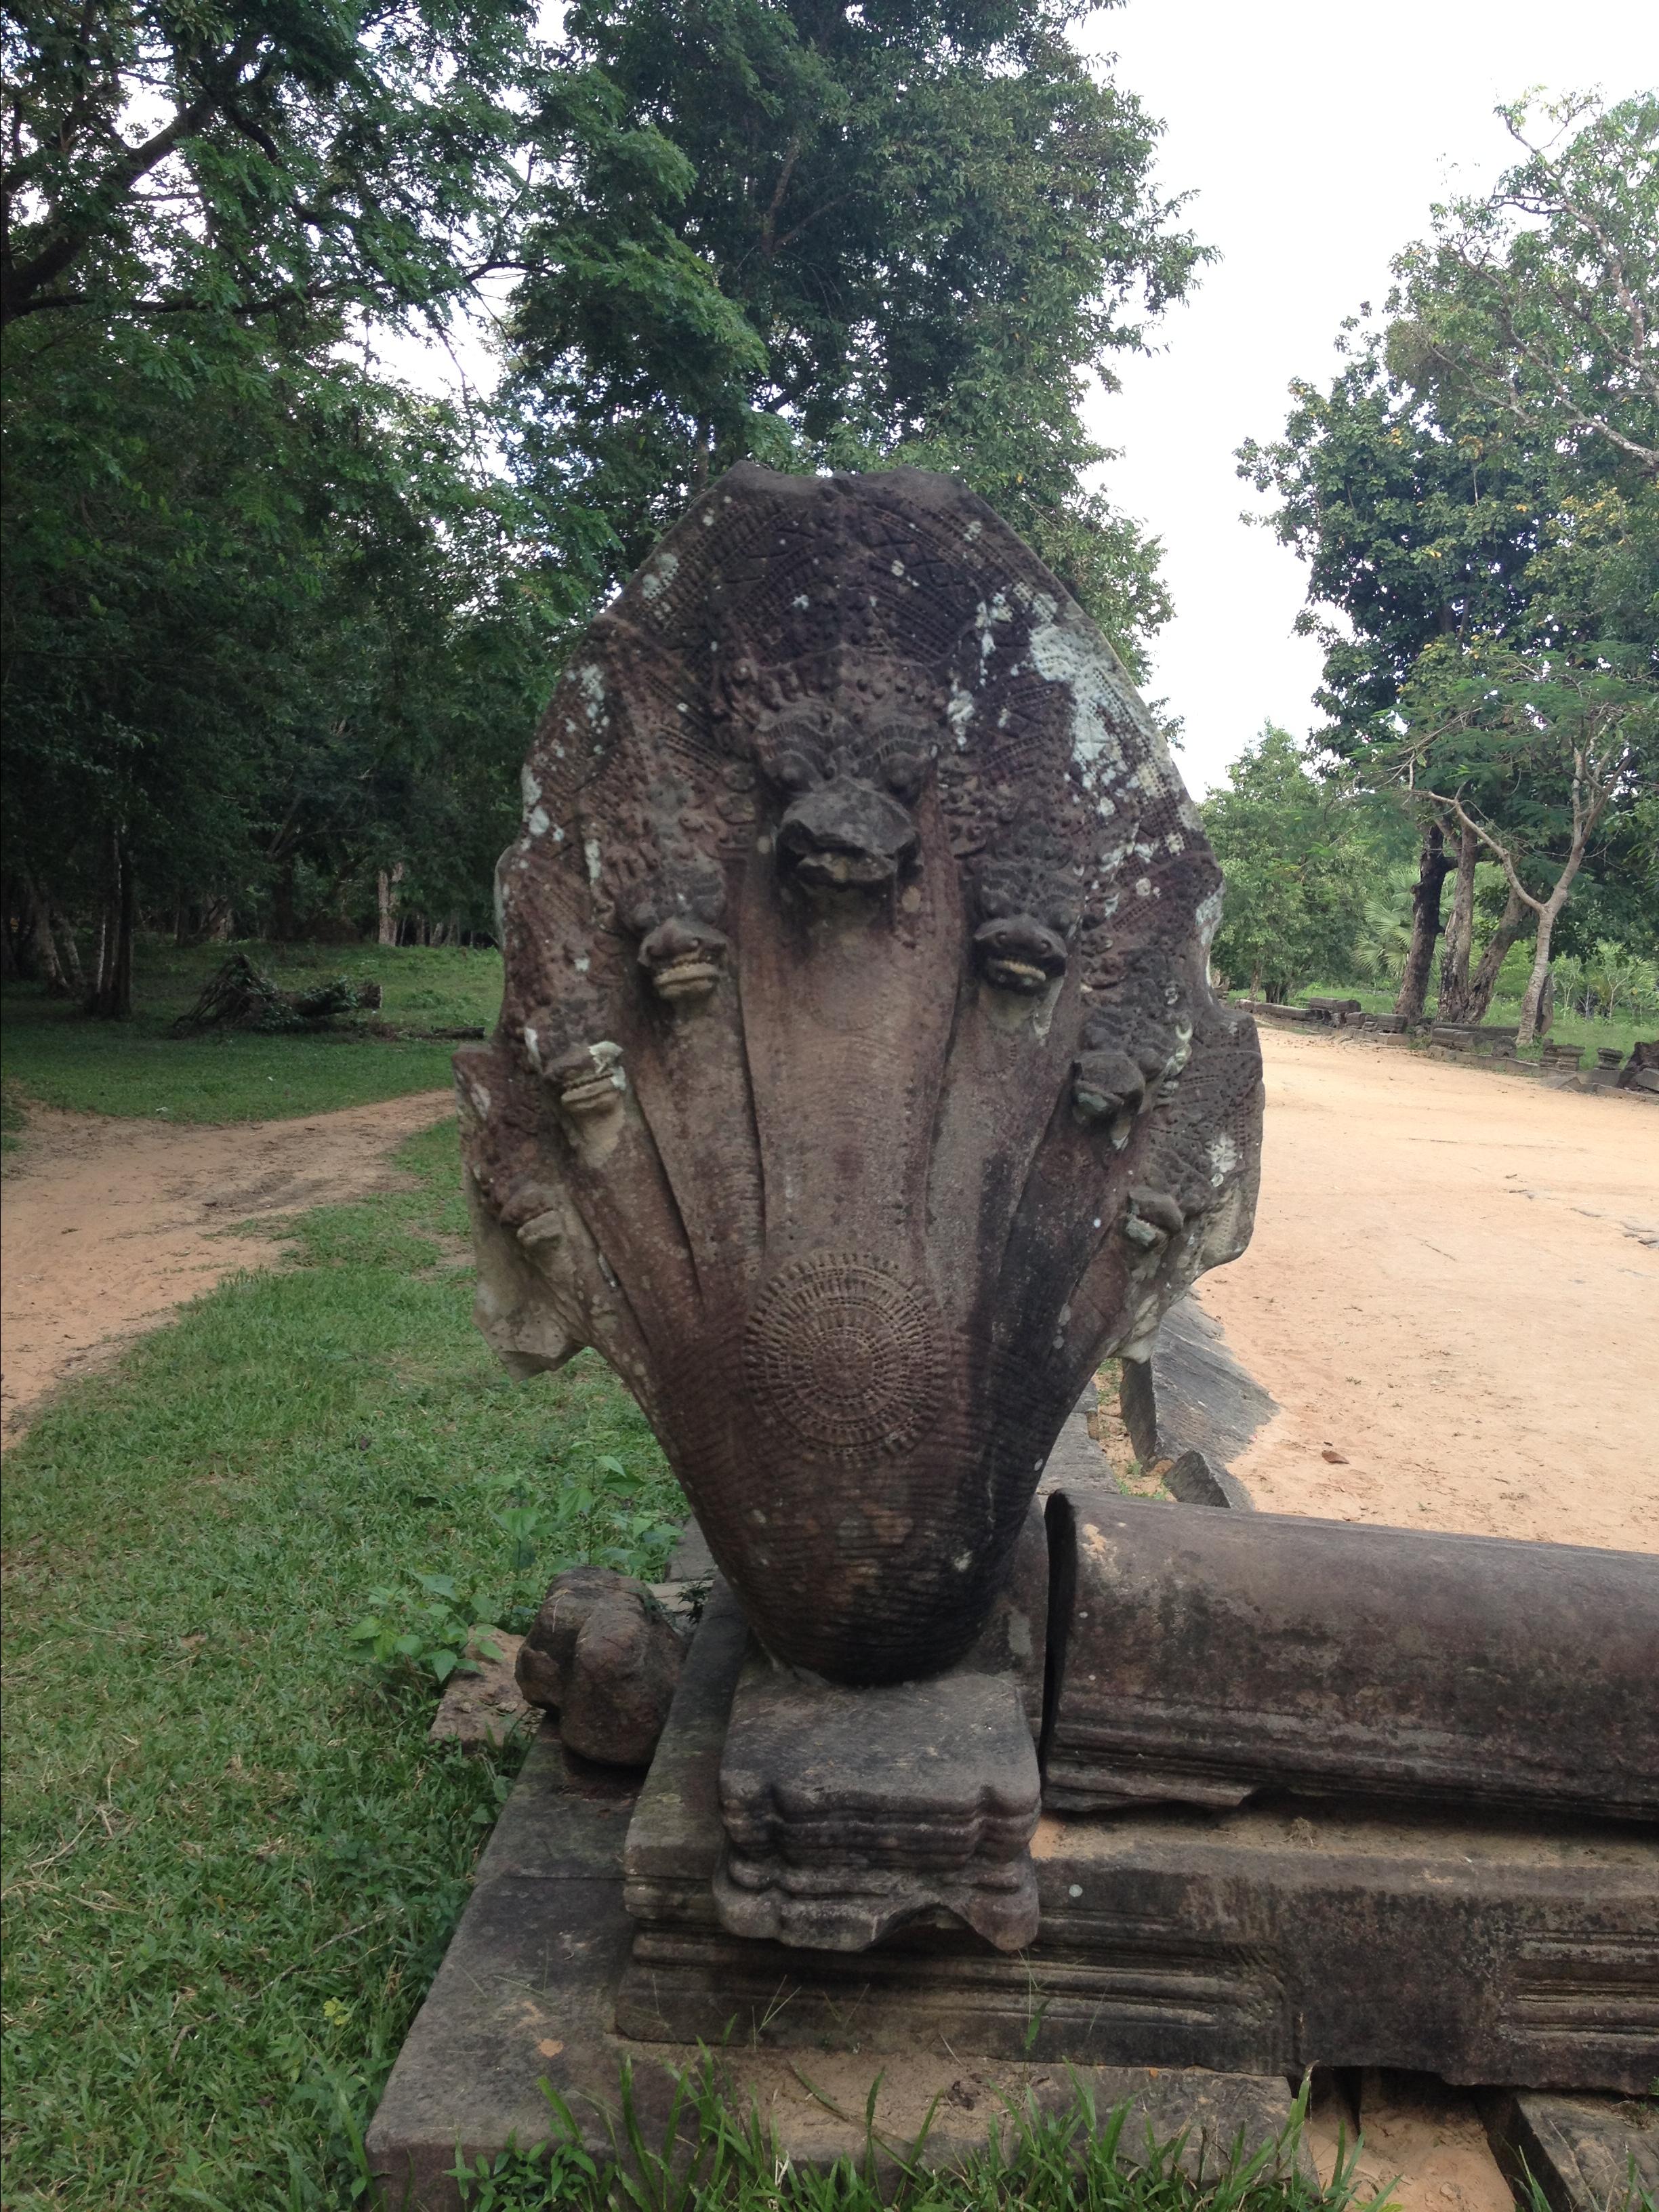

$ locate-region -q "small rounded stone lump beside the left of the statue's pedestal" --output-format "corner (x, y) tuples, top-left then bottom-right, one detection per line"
(518, 1566), (686, 1767)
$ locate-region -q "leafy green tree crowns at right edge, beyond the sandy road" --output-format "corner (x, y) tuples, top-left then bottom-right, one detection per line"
(1239, 95), (1659, 1008)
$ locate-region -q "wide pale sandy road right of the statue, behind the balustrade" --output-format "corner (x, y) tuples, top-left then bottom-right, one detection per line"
(1199, 1029), (1659, 1551)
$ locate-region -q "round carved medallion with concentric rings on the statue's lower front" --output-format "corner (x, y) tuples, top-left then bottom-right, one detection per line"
(743, 1252), (938, 1458)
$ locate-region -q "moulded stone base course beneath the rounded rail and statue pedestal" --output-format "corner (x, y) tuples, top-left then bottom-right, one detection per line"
(617, 1574), (1659, 2093)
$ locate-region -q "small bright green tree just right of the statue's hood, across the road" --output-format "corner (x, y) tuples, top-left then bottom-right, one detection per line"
(1201, 723), (1372, 1002)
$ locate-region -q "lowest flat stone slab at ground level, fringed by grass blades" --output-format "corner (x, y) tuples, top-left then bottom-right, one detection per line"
(367, 1727), (1290, 2212)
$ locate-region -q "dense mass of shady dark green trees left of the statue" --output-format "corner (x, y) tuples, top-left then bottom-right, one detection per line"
(0, 0), (558, 1015)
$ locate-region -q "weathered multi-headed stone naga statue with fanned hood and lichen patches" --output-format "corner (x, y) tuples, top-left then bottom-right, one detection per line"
(455, 464), (1261, 1685)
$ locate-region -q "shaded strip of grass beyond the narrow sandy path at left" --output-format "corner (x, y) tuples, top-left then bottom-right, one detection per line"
(0, 938), (502, 1122)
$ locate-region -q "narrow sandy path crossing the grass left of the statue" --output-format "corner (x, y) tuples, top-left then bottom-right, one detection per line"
(0, 1090), (451, 1442)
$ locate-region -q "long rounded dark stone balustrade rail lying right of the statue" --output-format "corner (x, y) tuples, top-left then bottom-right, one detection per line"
(1044, 1484), (1659, 1820)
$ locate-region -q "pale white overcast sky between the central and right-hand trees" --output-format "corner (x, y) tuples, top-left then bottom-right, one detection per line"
(1084, 0), (1659, 794)
